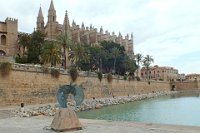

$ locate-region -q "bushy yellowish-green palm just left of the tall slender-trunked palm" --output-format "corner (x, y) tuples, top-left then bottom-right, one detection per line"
(41, 41), (62, 66)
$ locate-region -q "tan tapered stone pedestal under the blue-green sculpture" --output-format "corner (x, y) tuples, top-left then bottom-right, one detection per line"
(51, 108), (82, 131)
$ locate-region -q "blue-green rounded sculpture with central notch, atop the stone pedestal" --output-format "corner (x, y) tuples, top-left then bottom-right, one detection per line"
(57, 84), (84, 108)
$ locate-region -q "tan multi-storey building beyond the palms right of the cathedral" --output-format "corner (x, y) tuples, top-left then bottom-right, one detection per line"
(140, 66), (178, 81)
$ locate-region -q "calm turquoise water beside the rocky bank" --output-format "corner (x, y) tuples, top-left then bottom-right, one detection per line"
(78, 94), (200, 126)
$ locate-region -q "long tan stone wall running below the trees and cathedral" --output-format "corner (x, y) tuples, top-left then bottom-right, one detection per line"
(0, 65), (170, 105)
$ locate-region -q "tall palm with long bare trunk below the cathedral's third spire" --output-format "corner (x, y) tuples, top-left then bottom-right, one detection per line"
(57, 32), (72, 69)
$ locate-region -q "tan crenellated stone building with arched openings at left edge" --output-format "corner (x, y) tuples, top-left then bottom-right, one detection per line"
(0, 18), (18, 59)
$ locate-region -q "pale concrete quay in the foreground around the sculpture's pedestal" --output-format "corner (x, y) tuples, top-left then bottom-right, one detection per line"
(0, 116), (200, 133)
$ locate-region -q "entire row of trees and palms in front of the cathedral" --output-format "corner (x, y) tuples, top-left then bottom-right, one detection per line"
(16, 31), (137, 75)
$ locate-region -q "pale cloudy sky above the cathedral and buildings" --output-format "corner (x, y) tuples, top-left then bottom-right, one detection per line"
(0, 0), (200, 74)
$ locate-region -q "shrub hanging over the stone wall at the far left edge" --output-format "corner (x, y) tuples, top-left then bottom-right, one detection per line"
(0, 62), (12, 77)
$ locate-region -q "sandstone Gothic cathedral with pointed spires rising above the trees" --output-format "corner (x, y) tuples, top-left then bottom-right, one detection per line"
(37, 0), (134, 55)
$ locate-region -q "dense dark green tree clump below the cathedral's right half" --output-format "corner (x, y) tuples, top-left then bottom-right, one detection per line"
(79, 41), (137, 75)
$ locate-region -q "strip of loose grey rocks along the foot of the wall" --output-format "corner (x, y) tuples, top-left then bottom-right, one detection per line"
(12, 91), (178, 117)
